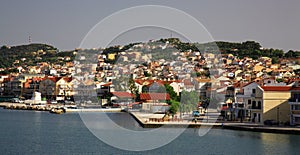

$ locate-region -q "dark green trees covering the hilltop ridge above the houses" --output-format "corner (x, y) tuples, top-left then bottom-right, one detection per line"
(0, 38), (300, 72)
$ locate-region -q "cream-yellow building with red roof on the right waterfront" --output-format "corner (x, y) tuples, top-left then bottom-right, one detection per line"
(251, 86), (291, 123)
